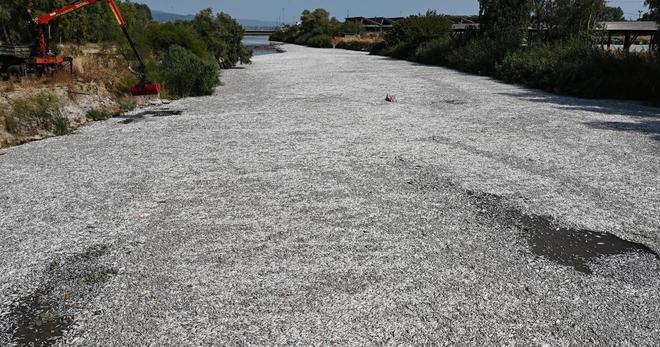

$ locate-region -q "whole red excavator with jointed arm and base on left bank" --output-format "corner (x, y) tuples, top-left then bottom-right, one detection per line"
(15, 0), (160, 95)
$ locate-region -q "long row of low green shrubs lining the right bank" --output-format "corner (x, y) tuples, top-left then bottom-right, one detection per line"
(371, 12), (660, 103)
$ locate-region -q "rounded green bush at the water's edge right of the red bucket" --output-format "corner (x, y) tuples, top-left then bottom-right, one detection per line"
(160, 46), (220, 97)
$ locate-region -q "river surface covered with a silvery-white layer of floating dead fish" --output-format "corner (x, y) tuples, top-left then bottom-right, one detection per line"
(0, 46), (660, 346)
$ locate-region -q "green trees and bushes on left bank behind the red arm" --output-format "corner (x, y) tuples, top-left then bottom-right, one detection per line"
(0, 0), (252, 97)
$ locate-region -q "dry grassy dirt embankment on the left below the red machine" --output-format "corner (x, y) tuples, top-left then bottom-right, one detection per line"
(0, 45), (147, 148)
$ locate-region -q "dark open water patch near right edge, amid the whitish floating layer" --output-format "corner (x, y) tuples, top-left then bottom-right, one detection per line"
(466, 191), (660, 274)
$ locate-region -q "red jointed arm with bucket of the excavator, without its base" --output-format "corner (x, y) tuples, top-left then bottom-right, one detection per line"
(30, 0), (160, 95)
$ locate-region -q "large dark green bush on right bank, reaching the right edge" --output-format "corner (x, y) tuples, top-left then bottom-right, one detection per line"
(496, 41), (660, 102)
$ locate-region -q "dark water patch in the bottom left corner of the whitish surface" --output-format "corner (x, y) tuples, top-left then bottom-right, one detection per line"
(0, 245), (118, 346)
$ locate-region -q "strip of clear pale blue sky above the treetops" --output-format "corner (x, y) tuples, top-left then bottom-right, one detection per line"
(135, 0), (646, 22)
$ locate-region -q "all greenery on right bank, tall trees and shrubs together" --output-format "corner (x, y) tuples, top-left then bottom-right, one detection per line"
(371, 0), (660, 103)
